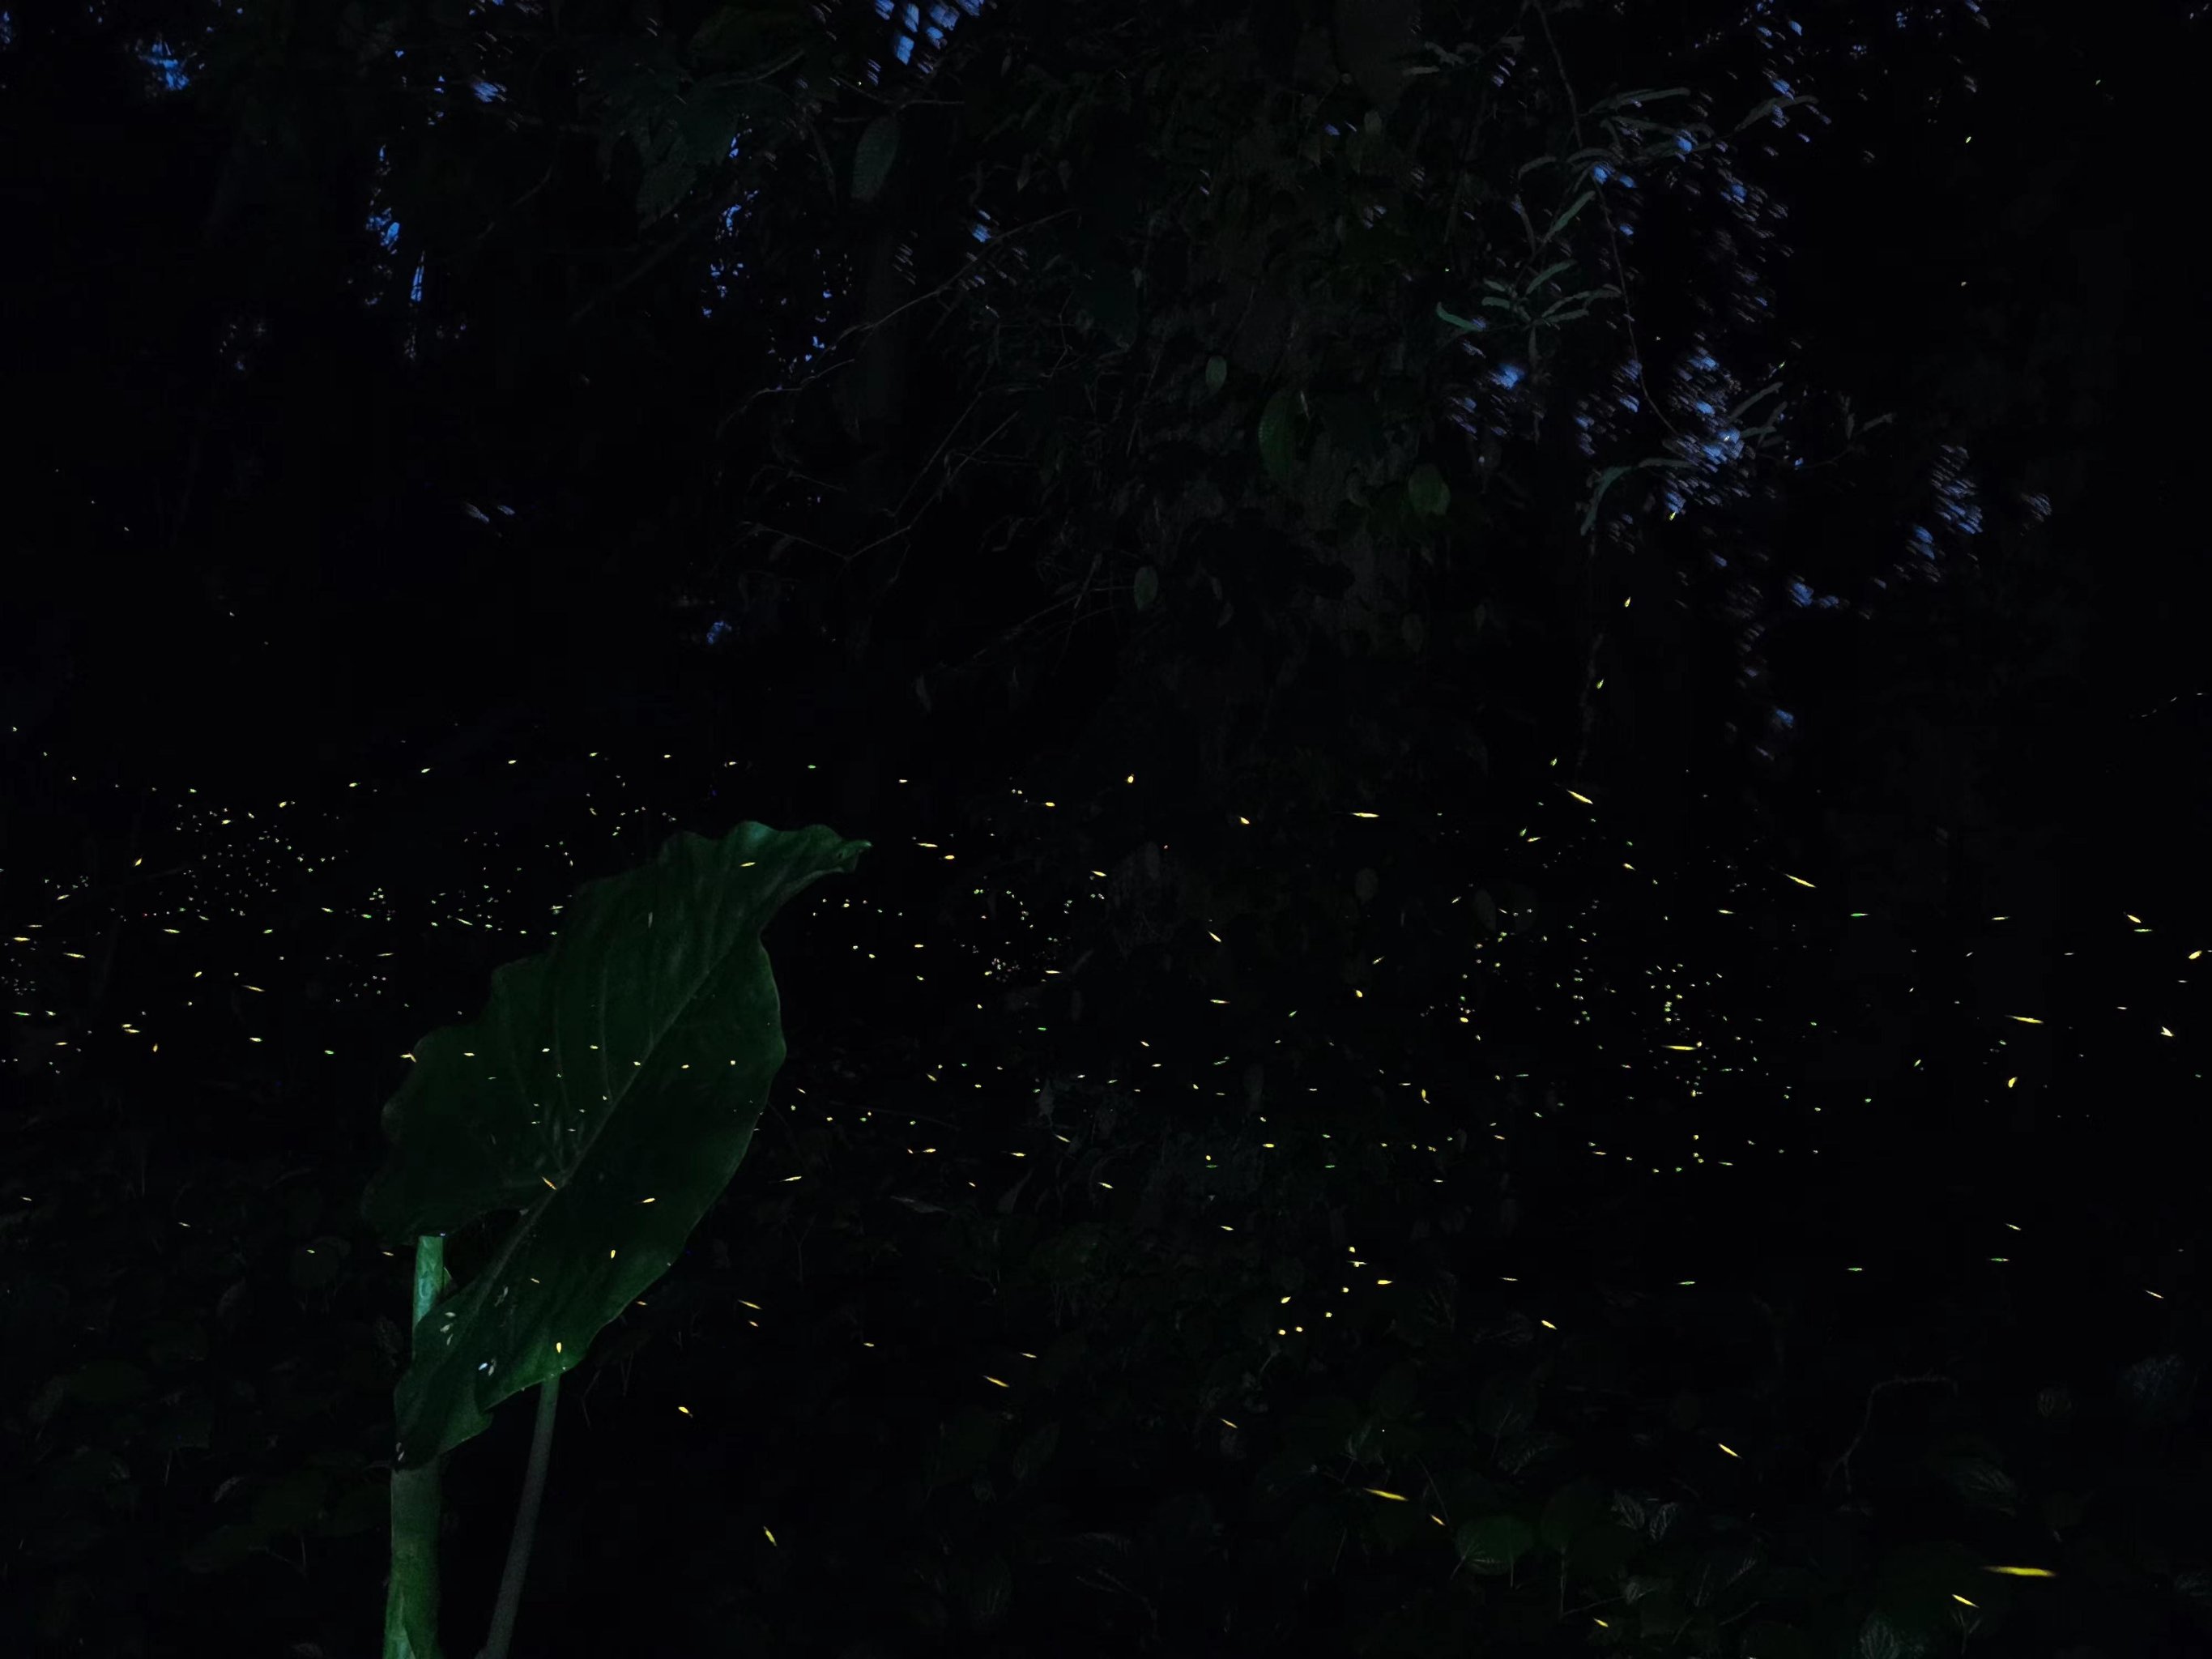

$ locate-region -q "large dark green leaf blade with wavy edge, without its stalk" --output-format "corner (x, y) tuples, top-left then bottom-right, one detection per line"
(363, 823), (867, 1466)
